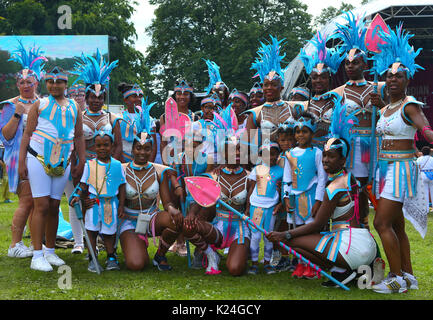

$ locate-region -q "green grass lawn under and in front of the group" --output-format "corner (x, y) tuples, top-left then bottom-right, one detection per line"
(0, 192), (433, 301)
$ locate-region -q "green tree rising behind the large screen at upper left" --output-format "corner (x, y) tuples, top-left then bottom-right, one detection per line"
(0, 0), (153, 104)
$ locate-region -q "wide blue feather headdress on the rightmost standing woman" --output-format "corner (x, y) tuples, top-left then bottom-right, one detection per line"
(372, 22), (424, 79)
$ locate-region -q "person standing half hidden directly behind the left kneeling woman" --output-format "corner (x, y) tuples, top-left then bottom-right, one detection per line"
(117, 82), (157, 162)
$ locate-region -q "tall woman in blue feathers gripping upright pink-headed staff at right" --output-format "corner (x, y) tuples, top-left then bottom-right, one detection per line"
(331, 11), (388, 227)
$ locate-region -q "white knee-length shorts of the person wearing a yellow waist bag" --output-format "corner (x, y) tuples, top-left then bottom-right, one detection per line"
(27, 153), (71, 200)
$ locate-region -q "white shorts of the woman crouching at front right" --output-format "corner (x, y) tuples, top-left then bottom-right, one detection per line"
(339, 228), (377, 270)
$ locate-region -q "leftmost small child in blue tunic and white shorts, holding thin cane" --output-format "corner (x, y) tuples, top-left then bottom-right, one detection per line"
(70, 131), (126, 272)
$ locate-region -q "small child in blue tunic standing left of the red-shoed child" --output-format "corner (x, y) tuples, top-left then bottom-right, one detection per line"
(248, 140), (284, 274)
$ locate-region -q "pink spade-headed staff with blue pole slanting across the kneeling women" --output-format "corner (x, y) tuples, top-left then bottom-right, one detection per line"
(185, 177), (350, 291)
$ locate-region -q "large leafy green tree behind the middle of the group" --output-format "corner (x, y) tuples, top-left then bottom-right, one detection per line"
(146, 0), (311, 112)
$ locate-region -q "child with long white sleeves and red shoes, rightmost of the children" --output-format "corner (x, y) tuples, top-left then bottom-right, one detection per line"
(283, 112), (327, 279)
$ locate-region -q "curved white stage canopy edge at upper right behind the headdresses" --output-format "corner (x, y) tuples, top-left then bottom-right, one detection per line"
(283, 0), (433, 98)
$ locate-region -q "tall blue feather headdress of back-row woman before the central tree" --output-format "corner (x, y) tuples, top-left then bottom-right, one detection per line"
(250, 36), (286, 84)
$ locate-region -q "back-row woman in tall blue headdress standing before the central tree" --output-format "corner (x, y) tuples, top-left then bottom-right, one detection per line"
(246, 36), (294, 146)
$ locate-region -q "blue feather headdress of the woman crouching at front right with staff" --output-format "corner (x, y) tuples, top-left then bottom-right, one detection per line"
(324, 97), (359, 158)
